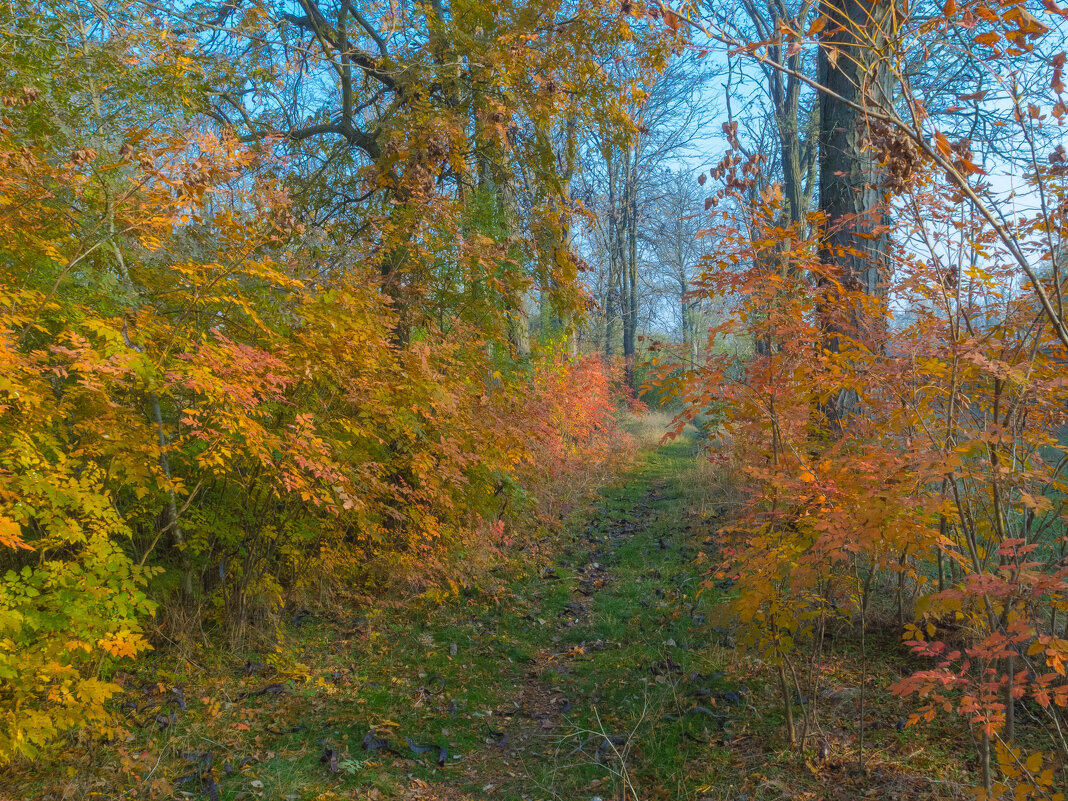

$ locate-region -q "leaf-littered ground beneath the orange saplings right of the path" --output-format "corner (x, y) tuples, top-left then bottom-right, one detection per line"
(677, 446), (977, 801)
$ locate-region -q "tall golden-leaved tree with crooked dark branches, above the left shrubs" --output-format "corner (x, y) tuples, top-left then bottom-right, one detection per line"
(147, 0), (662, 344)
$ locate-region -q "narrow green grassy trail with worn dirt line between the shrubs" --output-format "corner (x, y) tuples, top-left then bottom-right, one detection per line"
(393, 440), (741, 801)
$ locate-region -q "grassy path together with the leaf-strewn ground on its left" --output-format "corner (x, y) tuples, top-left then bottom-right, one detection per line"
(14, 441), (740, 801)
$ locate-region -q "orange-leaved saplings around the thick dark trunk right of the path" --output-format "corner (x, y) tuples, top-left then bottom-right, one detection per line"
(662, 3), (1068, 798)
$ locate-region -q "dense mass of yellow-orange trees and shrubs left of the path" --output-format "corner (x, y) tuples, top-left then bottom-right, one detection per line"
(0, 2), (663, 759)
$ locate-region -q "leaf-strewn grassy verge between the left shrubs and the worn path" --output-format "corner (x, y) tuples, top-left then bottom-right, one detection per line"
(0, 420), (649, 801)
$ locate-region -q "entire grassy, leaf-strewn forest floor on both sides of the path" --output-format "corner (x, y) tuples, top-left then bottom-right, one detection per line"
(12, 440), (967, 801)
